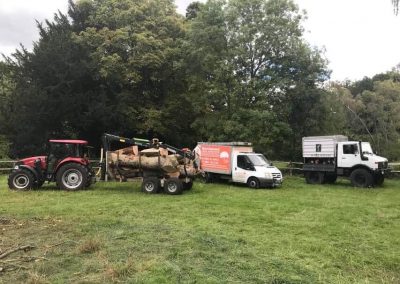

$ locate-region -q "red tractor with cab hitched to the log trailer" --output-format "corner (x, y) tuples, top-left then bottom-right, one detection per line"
(8, 140), (95, 190)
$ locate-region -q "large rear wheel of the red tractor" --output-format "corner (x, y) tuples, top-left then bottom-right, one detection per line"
(56, 163), (88, 191)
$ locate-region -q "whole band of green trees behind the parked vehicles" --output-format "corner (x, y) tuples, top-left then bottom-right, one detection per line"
(0, 0), (400, 160)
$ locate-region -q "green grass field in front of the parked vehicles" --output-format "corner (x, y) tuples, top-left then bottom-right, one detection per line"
(0, 176), (400, 283)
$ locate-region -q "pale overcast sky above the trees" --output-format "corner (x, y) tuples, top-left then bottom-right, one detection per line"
(0, 0), (400, 80)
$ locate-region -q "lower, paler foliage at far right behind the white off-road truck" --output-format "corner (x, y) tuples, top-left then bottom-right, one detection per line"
(331, 70), (400, 160)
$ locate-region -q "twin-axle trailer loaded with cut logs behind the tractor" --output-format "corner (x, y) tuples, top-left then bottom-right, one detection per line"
(101, 133), (197, 195)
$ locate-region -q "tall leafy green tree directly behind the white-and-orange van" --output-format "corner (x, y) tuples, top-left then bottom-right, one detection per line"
(186, 0), (329, 159)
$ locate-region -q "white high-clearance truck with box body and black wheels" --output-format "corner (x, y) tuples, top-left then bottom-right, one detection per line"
(303, 135), (389, 187)
